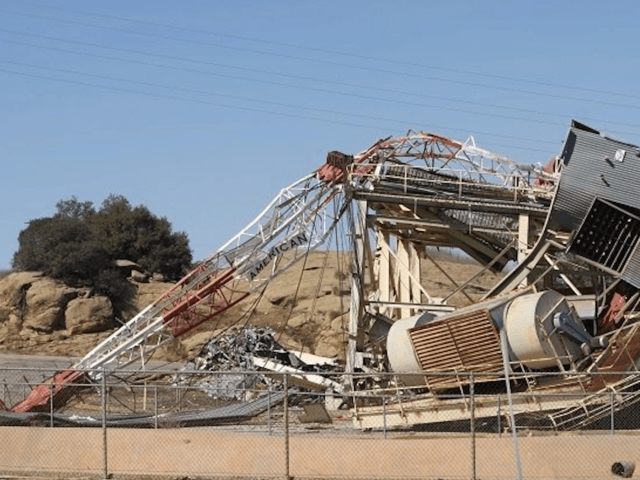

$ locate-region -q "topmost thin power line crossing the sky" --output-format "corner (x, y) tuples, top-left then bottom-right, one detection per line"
(16, 0), (640, 99)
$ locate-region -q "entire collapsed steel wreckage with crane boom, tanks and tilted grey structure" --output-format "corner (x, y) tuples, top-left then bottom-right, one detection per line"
(8, 121), (640, 428)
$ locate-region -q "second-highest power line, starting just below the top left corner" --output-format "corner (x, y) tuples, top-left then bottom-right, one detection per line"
(5, 9), (640, 110)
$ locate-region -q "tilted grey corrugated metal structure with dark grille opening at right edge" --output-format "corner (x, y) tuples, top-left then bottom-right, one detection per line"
(549, 120), (640, 287)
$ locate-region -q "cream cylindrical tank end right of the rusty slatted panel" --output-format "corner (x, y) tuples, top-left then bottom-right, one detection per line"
(504, 290), (583, 369)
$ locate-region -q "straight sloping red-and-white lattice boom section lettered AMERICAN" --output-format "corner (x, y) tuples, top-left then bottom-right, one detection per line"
(12, 174), (348, 412)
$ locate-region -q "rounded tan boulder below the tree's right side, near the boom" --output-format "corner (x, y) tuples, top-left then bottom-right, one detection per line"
(64, 296), (114, 335)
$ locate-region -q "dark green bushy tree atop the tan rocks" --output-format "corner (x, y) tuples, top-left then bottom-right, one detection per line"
(12, 194), (192, 304)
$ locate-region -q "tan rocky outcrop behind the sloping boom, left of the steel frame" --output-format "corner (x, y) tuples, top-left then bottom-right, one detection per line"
(0, 254), (360, 358)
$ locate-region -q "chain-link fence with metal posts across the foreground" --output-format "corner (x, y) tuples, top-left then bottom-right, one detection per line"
(0, 368), (640, 480)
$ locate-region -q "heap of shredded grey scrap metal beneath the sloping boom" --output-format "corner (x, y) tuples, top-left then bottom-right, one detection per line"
(173, 325), (341, 400)
